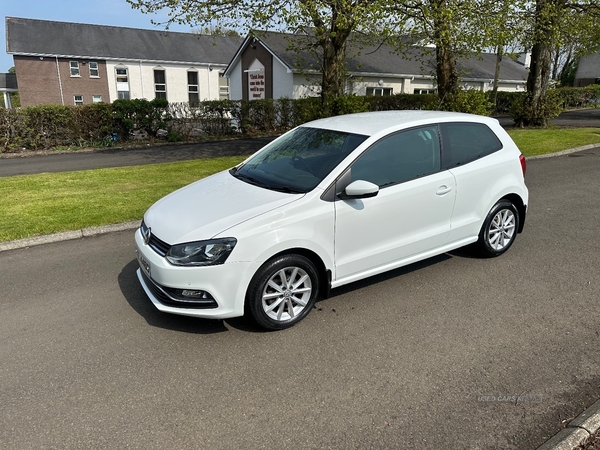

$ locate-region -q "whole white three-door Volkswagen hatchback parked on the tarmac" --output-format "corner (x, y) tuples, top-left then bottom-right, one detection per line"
(135, 111), (528, 329)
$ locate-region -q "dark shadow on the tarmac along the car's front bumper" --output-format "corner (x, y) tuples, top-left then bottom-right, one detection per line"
(118, 259), (231, 334)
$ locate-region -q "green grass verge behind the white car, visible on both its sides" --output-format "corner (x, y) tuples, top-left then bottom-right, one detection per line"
(0, 128), (600, 242)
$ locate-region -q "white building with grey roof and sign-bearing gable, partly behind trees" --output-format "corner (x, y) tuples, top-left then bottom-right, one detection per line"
(224, 32), (527, 100)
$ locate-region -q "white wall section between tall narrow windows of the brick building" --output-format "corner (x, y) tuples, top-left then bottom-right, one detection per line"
(106, 61), (225, 103)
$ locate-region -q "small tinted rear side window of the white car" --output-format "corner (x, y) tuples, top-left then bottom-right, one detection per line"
(441, 122), (502, 168)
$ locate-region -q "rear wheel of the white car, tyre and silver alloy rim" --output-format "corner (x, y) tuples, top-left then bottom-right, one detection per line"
(477, 200), (519, 257)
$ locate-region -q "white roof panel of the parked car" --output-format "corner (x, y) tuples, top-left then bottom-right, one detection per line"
(302, 110), (498, 136)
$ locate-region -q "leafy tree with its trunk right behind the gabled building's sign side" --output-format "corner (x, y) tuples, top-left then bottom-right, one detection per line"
(127, 0), (403, 102)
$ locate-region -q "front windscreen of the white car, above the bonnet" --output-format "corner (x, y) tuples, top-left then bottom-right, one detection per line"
(231, 127), (368, 193)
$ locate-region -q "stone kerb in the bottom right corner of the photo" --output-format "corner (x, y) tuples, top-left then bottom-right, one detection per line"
(537, 400), (600, 450)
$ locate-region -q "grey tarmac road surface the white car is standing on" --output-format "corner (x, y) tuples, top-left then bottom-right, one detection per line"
(0, 149), (600, 449)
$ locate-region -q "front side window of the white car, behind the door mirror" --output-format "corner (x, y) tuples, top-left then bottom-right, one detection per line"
(351, 126), (440, 188)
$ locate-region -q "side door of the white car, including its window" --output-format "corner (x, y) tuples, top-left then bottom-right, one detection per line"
(334, 126), (456, 284)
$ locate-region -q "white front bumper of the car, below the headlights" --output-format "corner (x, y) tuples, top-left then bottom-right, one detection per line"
(135, 229), (254, 319)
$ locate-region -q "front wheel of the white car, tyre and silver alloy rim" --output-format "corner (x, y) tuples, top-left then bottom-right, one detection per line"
(246, 255), (319, 330)
